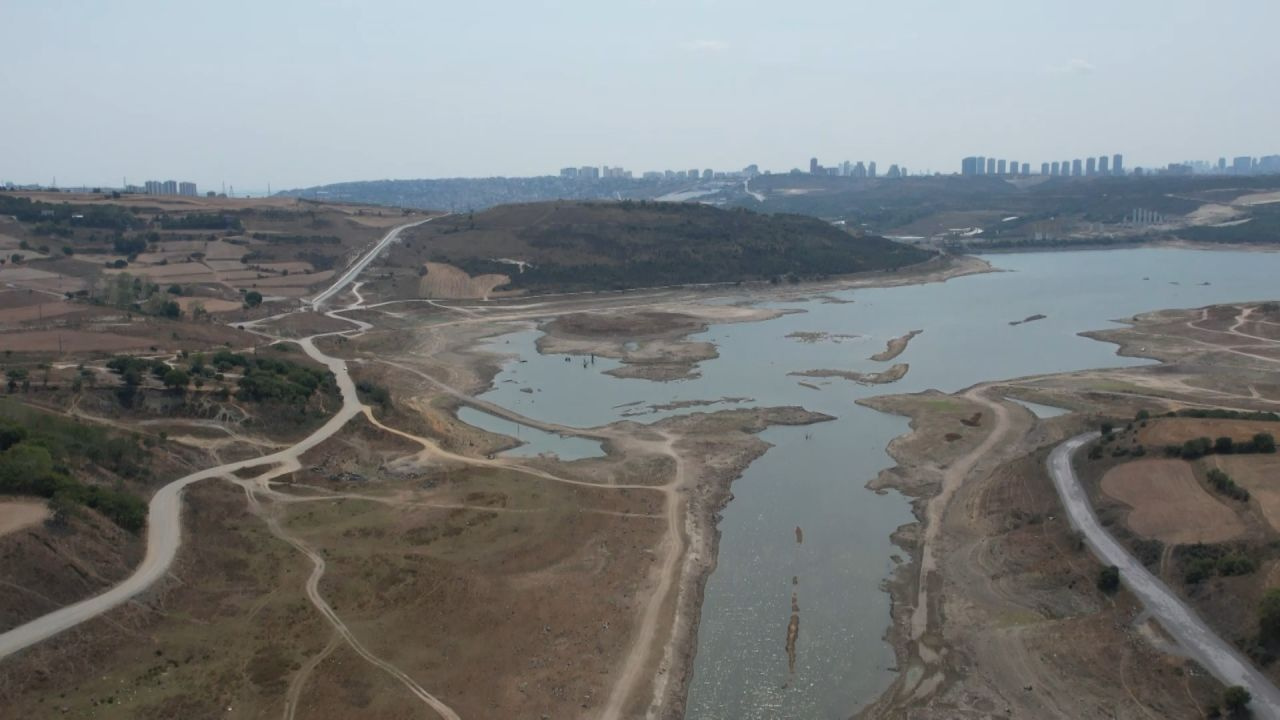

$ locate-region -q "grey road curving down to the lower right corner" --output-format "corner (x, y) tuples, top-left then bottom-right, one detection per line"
(1048, 432), (1280, 719)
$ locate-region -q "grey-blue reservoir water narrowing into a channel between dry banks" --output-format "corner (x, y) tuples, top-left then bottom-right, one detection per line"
(465, 249), (1280, 720)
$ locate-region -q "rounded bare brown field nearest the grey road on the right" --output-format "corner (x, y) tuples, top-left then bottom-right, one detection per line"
(1102, 460), (1244, 544)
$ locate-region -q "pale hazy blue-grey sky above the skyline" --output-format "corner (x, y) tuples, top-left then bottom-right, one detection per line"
(0, 0), (1280, 190)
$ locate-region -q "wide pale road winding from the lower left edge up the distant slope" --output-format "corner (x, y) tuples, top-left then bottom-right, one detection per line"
(0, 218), (430, 659)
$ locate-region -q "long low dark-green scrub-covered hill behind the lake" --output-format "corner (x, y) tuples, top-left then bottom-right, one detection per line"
(396, 201), (932, 291)
